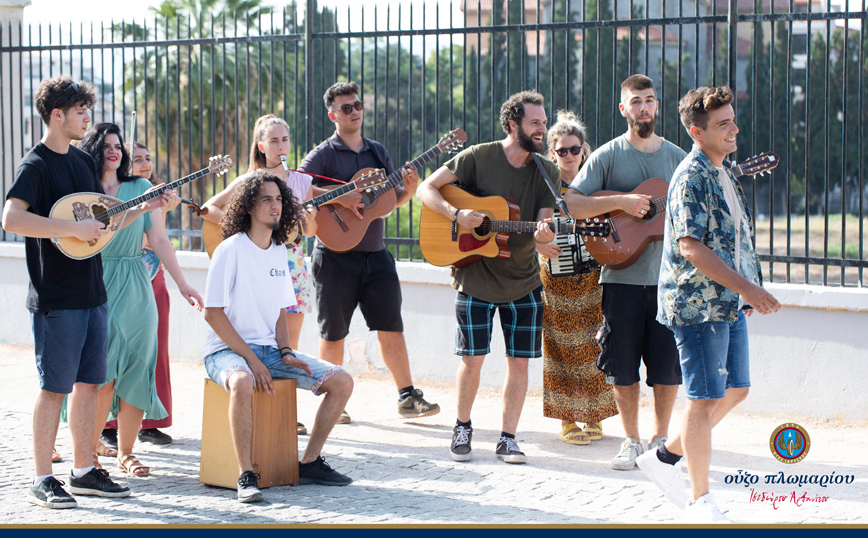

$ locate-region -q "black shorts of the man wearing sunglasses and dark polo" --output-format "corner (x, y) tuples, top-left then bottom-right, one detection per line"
(311, 248), (404, 342)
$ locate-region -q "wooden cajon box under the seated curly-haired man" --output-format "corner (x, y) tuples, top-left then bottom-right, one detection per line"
(199, 378), (298, 489)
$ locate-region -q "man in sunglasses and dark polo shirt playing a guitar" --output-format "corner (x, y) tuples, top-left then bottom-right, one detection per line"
(299, 82), (440, 424)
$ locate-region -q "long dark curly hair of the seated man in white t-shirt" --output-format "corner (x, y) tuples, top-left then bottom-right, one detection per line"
(220, 170), (300, 245)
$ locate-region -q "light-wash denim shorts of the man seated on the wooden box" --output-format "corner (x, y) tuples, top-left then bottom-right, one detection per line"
(205, 345), (343, 396)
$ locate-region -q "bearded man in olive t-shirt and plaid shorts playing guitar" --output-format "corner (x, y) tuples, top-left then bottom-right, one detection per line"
(419, 91), (560, 463)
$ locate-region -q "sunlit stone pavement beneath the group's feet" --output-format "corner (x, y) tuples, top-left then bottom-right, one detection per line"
(0, 344), (868, 525)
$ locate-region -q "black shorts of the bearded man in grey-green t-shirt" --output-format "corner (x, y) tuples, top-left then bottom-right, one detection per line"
(597, 283), (681, 387)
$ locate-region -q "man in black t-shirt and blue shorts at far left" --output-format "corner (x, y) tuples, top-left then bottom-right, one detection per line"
(3, 77), (168, 508)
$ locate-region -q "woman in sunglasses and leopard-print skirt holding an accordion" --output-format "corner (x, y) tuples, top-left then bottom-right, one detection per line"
(537, 110), (618, 445)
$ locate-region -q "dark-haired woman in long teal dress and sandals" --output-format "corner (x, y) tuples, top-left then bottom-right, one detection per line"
(79, 123), (203, 476)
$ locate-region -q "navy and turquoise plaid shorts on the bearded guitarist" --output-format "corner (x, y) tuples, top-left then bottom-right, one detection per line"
(455, 286), (543, 359)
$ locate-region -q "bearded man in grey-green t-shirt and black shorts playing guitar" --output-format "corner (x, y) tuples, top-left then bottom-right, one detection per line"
(564, 75), (687, 470)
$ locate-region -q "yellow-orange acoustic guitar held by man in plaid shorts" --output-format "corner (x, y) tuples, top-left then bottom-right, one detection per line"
(419, 185), (609, 267)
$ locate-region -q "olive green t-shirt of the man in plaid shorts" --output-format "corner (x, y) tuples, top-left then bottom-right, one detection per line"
(444, 142), (560, 303)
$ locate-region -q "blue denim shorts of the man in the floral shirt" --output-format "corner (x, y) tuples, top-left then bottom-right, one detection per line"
(669, 310), (750, 400)
